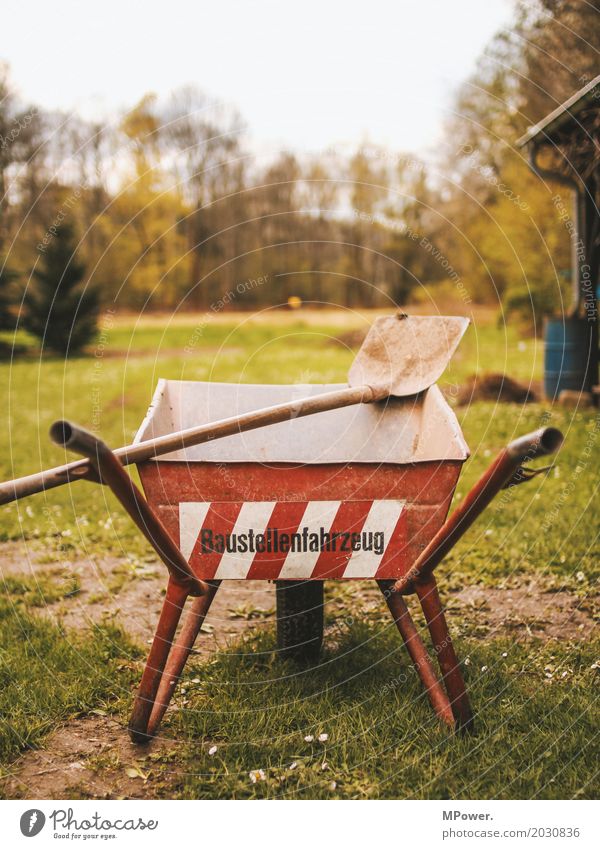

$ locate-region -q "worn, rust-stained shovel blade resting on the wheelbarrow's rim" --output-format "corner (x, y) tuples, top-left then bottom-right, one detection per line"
(348, 314), (469, 397)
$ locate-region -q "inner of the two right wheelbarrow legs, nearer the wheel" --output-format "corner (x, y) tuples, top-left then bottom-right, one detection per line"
(378, 581), (454, 727)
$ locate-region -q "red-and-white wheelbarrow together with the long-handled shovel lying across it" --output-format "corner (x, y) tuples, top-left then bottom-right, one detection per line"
(0, 318), (562, 743)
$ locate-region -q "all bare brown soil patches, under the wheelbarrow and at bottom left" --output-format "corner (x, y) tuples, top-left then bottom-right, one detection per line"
(0, 544), (600, 799)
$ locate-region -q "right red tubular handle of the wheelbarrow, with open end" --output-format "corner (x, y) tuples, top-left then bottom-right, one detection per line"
(393, 427), (563, 593)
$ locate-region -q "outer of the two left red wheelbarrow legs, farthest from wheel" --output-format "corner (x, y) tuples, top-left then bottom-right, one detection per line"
(129, 579), (188, 743)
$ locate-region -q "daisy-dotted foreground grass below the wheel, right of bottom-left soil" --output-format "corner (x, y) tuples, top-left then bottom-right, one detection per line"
(156, 621), (600, 799)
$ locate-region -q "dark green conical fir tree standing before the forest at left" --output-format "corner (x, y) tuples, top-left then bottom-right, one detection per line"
(23, 221), (99, 356)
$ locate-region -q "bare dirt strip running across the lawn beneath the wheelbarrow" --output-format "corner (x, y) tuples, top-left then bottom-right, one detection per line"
(0, 543), (600, 652)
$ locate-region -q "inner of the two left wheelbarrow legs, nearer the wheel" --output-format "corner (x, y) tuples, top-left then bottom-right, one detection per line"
(148, 581), (221, 737)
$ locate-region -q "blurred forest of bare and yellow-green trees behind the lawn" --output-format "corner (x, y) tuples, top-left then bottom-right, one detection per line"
(0, 0), (600, 338)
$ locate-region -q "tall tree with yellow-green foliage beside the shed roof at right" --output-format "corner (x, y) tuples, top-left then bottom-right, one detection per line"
(432, 0), (600, 327)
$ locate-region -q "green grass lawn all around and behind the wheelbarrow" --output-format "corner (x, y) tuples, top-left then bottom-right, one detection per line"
(0, 313), (600, 798)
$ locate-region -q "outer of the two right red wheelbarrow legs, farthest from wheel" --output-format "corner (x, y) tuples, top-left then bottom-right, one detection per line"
(415, 574), (473, 731)
